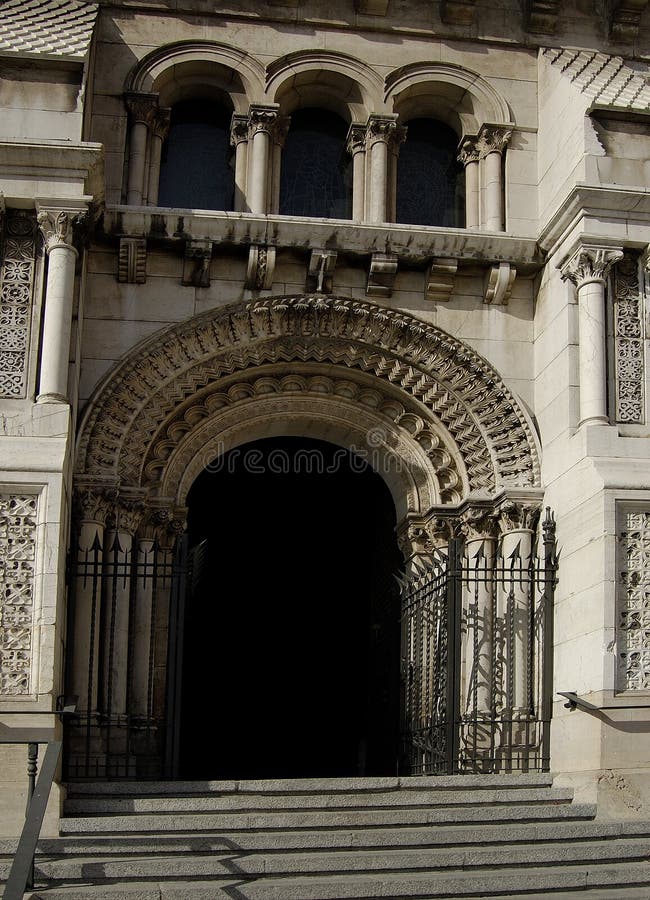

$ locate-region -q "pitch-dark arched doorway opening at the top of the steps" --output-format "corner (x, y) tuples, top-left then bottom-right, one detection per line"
(179, 438), (401, 779)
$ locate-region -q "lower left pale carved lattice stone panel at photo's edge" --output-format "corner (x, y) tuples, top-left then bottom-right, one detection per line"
(0, 494), (38, 695)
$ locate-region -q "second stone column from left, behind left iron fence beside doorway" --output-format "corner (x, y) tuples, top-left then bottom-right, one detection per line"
(102, 495), (143, 720)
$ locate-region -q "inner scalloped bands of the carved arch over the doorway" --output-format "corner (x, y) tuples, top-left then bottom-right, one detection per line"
(142, 366), (467, 513)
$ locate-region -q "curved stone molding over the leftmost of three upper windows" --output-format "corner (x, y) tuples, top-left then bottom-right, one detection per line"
(125, 41), (264, 108)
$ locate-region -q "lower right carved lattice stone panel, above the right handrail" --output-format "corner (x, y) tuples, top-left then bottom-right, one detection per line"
(616, 509), (650, 691)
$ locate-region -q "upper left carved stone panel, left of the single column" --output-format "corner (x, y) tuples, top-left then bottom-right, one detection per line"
(0, 210), (36, 398)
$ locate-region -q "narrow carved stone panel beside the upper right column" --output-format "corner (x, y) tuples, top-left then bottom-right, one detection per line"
(612, 251), (645, 425)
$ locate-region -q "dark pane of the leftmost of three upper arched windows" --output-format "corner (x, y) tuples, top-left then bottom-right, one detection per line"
(158, 99), (234, 209)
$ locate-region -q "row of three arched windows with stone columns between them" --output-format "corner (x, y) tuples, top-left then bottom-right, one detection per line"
(125, 52), (510, 230)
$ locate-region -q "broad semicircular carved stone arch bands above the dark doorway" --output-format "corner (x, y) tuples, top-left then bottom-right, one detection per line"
(76, 295), (539, 511)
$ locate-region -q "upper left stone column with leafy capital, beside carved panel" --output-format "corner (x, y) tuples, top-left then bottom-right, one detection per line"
(36, 208), (80, 403)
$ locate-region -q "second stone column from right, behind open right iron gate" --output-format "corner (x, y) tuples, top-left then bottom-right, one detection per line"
(460, 507), (497, 721)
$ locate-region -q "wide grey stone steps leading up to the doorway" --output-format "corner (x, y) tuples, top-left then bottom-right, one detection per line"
(0, 775), (650, 900)
